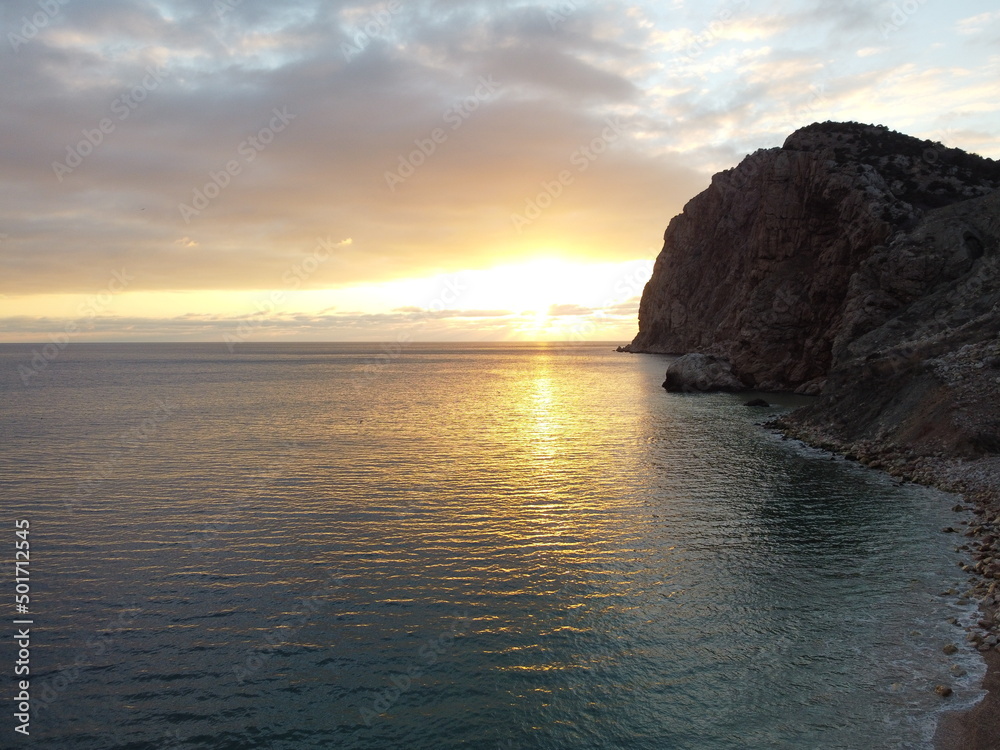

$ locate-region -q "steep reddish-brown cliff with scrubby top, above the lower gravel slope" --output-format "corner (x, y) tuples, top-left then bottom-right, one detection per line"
(629, 123), (1000, 393)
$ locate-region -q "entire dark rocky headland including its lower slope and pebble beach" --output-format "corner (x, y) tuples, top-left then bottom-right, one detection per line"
(625, 123), (1000, 749)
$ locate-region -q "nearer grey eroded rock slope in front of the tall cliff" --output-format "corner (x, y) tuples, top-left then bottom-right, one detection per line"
(785, 192), (1000, 458)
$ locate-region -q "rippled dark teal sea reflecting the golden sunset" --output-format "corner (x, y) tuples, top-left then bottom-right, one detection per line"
(0, 343), (983, 750)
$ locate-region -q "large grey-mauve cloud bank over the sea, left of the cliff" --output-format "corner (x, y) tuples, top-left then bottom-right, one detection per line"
(0, 0), (701, 300)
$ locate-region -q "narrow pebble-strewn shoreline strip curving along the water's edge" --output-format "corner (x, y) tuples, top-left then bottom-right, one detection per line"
(764, 414), (1000, 750)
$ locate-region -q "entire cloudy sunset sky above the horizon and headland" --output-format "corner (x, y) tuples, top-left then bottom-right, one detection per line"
(0, 0), (1000, 346)
